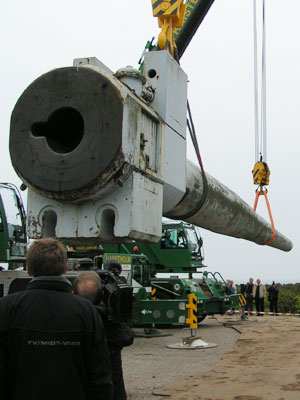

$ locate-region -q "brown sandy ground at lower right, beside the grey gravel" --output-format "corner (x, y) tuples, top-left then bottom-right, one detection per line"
(155, 316), (300, 400)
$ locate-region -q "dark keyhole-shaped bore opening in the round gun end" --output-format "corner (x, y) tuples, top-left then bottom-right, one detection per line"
(31, 107), (84, 154)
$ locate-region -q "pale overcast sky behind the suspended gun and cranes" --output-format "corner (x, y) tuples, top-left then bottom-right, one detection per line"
(0, 0), (300, 283)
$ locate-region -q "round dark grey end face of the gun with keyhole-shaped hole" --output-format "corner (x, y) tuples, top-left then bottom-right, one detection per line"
(10, 67), (123, 201)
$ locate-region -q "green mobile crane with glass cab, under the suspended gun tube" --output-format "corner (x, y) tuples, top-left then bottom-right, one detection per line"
(103, 221), (239, 324)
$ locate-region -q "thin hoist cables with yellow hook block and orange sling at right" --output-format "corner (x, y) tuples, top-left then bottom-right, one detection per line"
(252, 0), (276, 245)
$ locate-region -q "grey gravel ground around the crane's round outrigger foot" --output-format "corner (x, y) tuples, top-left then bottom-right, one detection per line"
(122, 317), (239, 400)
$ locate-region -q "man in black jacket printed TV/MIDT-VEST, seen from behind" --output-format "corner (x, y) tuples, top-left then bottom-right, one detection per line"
(0, 239), (112, 400)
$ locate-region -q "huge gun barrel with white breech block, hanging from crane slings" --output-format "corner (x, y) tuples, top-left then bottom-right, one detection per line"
(10, 51), (292, 251)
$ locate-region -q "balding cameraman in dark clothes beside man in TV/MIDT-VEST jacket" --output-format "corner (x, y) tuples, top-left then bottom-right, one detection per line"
(73, 268), (134, 400)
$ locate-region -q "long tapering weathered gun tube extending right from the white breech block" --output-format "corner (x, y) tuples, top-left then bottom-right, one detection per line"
(167, 160), (293, 251)
